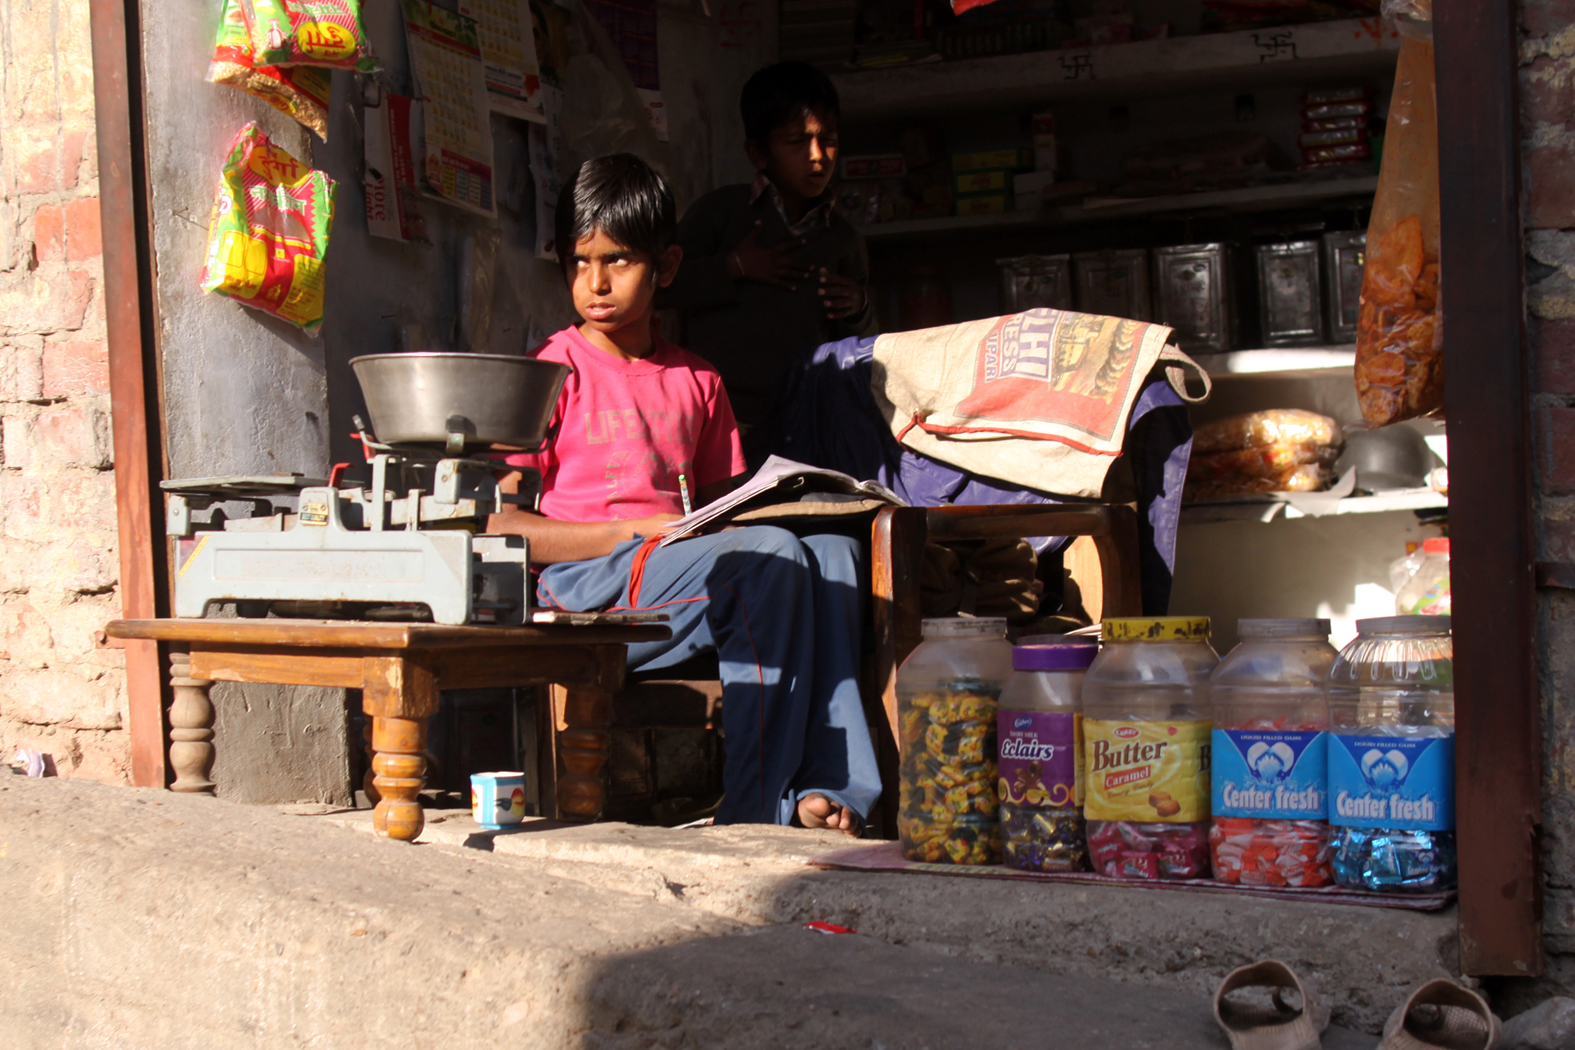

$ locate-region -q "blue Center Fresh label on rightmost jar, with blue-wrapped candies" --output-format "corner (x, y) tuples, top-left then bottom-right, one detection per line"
(1329, 734), (1455, 831)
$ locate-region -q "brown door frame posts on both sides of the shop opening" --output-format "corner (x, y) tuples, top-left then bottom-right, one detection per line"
(90, 0), (1542, 976)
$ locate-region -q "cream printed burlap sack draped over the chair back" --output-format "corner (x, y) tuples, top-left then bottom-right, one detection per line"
(871, 309), (1210, 497)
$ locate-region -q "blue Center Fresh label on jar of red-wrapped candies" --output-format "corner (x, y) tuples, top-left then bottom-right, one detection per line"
(1213, 729), (1329, 820)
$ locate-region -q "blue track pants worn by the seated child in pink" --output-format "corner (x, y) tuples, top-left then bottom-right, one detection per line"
(537, 526), (880, 823)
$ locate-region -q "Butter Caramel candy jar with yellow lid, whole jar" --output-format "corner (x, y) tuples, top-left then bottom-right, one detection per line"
(1084, 616), (1219, 878)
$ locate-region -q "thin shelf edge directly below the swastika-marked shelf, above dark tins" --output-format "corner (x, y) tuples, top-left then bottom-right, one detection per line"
(863, 175), (1378, 241)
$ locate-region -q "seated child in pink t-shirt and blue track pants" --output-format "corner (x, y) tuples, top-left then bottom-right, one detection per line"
(488, 154), (880, 834)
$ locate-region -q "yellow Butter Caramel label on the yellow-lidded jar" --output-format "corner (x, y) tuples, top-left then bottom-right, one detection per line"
(1084, 718), (1211, 823)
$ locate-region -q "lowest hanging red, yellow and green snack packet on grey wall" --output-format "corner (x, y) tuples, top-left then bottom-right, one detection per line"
(202, 123), (334, 332)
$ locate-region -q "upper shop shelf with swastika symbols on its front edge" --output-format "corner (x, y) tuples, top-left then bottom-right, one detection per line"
(832, 19), (1400, 123)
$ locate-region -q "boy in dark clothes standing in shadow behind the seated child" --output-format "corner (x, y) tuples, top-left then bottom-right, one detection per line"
(662, 61), (876, 464)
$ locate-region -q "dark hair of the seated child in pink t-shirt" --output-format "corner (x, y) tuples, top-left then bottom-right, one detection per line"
(553, 153), (679, 269)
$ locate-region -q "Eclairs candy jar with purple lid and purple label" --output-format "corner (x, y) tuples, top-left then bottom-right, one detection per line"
(995, 639), (1099, 872)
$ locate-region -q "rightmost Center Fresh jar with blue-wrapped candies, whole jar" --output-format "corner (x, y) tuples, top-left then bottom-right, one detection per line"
(1325, 616), (1457, 893)
